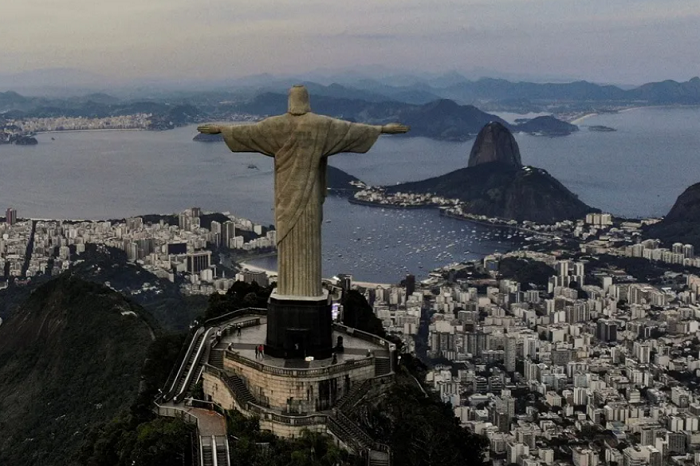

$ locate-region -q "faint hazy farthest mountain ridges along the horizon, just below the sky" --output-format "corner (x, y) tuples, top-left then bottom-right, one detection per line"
(0, 68), (700, 109)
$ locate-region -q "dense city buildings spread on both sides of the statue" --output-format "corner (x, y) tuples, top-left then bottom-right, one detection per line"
(0, 204), (700, 466)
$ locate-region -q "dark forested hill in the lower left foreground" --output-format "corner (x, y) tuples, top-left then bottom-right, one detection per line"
(0, 274), (154, 466)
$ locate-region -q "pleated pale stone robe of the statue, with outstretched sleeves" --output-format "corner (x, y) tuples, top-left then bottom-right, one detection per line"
(222, 112), (381, 297)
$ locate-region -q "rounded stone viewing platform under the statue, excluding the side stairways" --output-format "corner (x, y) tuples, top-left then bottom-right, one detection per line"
(202, 316), (395, 428)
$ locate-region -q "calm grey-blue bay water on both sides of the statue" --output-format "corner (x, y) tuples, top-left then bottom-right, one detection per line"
(0, 108), (700, 282)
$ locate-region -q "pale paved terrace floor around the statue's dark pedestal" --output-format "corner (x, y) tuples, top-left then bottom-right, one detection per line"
(216, 316), (389, 369)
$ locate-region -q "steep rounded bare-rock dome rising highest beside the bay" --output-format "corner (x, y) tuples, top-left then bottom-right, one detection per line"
(468, 121), (523, 167)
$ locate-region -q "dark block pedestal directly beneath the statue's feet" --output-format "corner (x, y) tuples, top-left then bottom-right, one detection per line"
(265, 290), (333, 359)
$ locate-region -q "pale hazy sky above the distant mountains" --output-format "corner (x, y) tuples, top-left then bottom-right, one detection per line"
(5, 0), (700, 83)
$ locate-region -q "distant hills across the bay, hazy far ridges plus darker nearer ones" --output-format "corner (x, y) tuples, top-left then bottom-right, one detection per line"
(0, 75), (700, 141)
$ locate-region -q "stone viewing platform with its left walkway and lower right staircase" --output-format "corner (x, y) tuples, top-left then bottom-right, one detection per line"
(159, 308), (396, 464)
